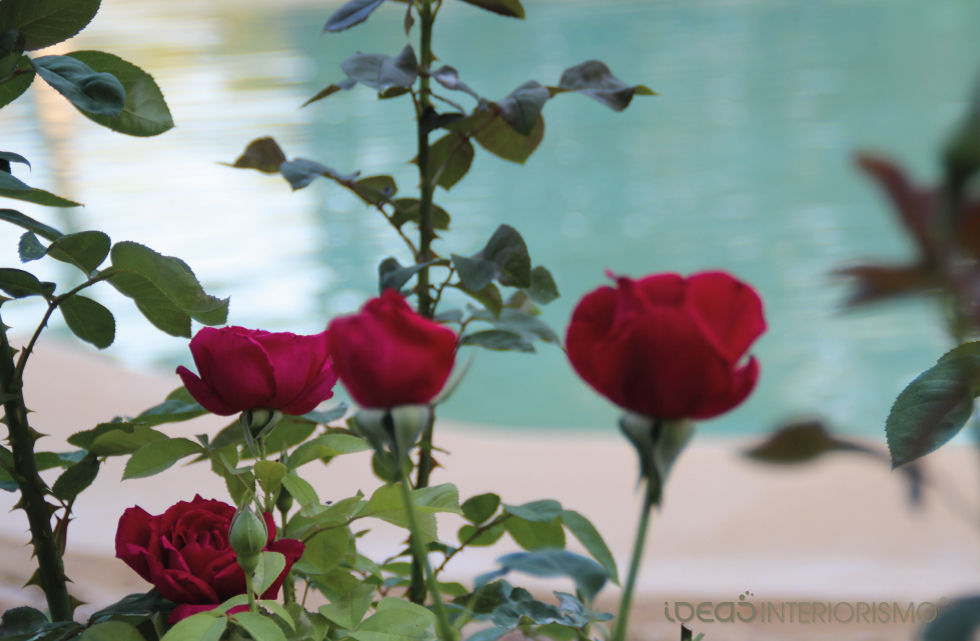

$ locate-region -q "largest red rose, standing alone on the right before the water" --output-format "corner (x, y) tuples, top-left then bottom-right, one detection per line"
(565, 272), (766, 419)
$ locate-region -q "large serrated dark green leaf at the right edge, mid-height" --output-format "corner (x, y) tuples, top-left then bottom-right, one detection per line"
(885, 342), (980, 468)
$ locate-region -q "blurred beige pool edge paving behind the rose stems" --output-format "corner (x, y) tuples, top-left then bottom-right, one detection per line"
(0, 344), (980, 641)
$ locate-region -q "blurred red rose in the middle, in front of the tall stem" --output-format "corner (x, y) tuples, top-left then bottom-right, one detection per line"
(327, 289), (456, 407)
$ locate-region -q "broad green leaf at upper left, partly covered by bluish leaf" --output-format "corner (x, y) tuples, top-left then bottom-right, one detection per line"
(68, 51), (174, 136)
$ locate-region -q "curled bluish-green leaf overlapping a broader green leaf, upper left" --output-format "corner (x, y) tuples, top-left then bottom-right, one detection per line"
(31, 56), (126, 118)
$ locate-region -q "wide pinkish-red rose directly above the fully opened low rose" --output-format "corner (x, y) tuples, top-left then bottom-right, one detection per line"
(177, 327), (337, 416)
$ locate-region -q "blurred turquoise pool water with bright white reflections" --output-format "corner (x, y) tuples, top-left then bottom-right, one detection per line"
(0, 0), (980, 435)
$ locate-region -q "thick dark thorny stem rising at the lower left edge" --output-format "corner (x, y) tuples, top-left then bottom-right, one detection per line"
(0, 320), (72, 621)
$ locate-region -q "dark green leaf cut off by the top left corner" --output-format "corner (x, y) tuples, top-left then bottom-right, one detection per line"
(0, 0), (100, 51)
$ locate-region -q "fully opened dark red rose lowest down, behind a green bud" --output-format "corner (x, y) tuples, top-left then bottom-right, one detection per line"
(116, 495), (304, 623)
